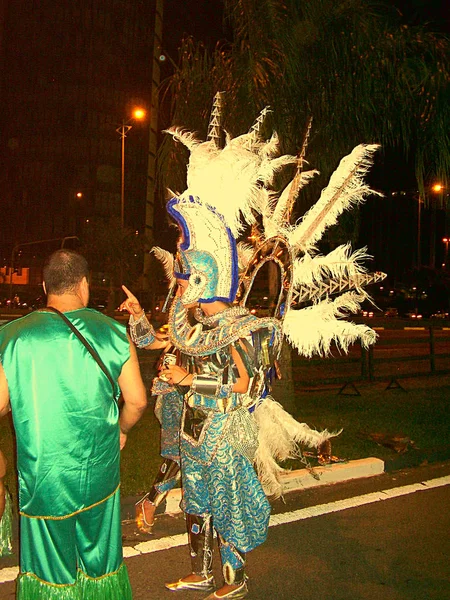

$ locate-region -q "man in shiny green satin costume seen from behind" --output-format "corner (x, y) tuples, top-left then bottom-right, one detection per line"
(0, 250), (147, 600)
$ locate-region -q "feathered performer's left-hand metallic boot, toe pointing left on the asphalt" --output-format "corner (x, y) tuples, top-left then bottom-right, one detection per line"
(166, 514), (214, 592)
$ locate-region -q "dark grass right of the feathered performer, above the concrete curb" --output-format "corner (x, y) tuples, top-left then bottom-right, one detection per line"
(294, 378), (450, 460)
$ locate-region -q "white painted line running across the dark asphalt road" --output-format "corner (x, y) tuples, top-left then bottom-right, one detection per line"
(0, 475), (450, 584)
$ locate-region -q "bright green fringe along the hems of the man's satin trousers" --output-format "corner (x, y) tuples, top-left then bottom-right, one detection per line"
(17, 563), (132, 600)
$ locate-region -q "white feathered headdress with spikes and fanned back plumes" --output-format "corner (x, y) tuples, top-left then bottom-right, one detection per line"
(156, 94), (385, 357)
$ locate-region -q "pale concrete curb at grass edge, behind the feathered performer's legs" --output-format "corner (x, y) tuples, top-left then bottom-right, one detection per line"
(160, 458), (384, 515)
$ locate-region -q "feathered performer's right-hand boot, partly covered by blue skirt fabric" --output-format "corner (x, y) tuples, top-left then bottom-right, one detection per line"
(206, 534), (248, 600)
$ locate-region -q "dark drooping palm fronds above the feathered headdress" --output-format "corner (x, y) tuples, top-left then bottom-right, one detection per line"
(159, 0), (450, 214)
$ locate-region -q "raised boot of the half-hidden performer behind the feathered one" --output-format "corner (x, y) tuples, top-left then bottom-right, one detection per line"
(135, 458), (180, 533)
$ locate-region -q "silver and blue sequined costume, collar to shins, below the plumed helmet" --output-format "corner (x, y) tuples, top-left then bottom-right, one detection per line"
(131, 299), (280, 584)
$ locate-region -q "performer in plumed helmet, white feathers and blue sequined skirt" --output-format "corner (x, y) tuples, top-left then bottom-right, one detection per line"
(125, 94), (384, 600)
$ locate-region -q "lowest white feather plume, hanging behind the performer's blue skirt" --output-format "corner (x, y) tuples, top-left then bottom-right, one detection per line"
(253, 396), (340, 497)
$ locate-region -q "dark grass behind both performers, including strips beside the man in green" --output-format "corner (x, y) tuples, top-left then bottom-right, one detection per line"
(0, 352), (450, 497)
